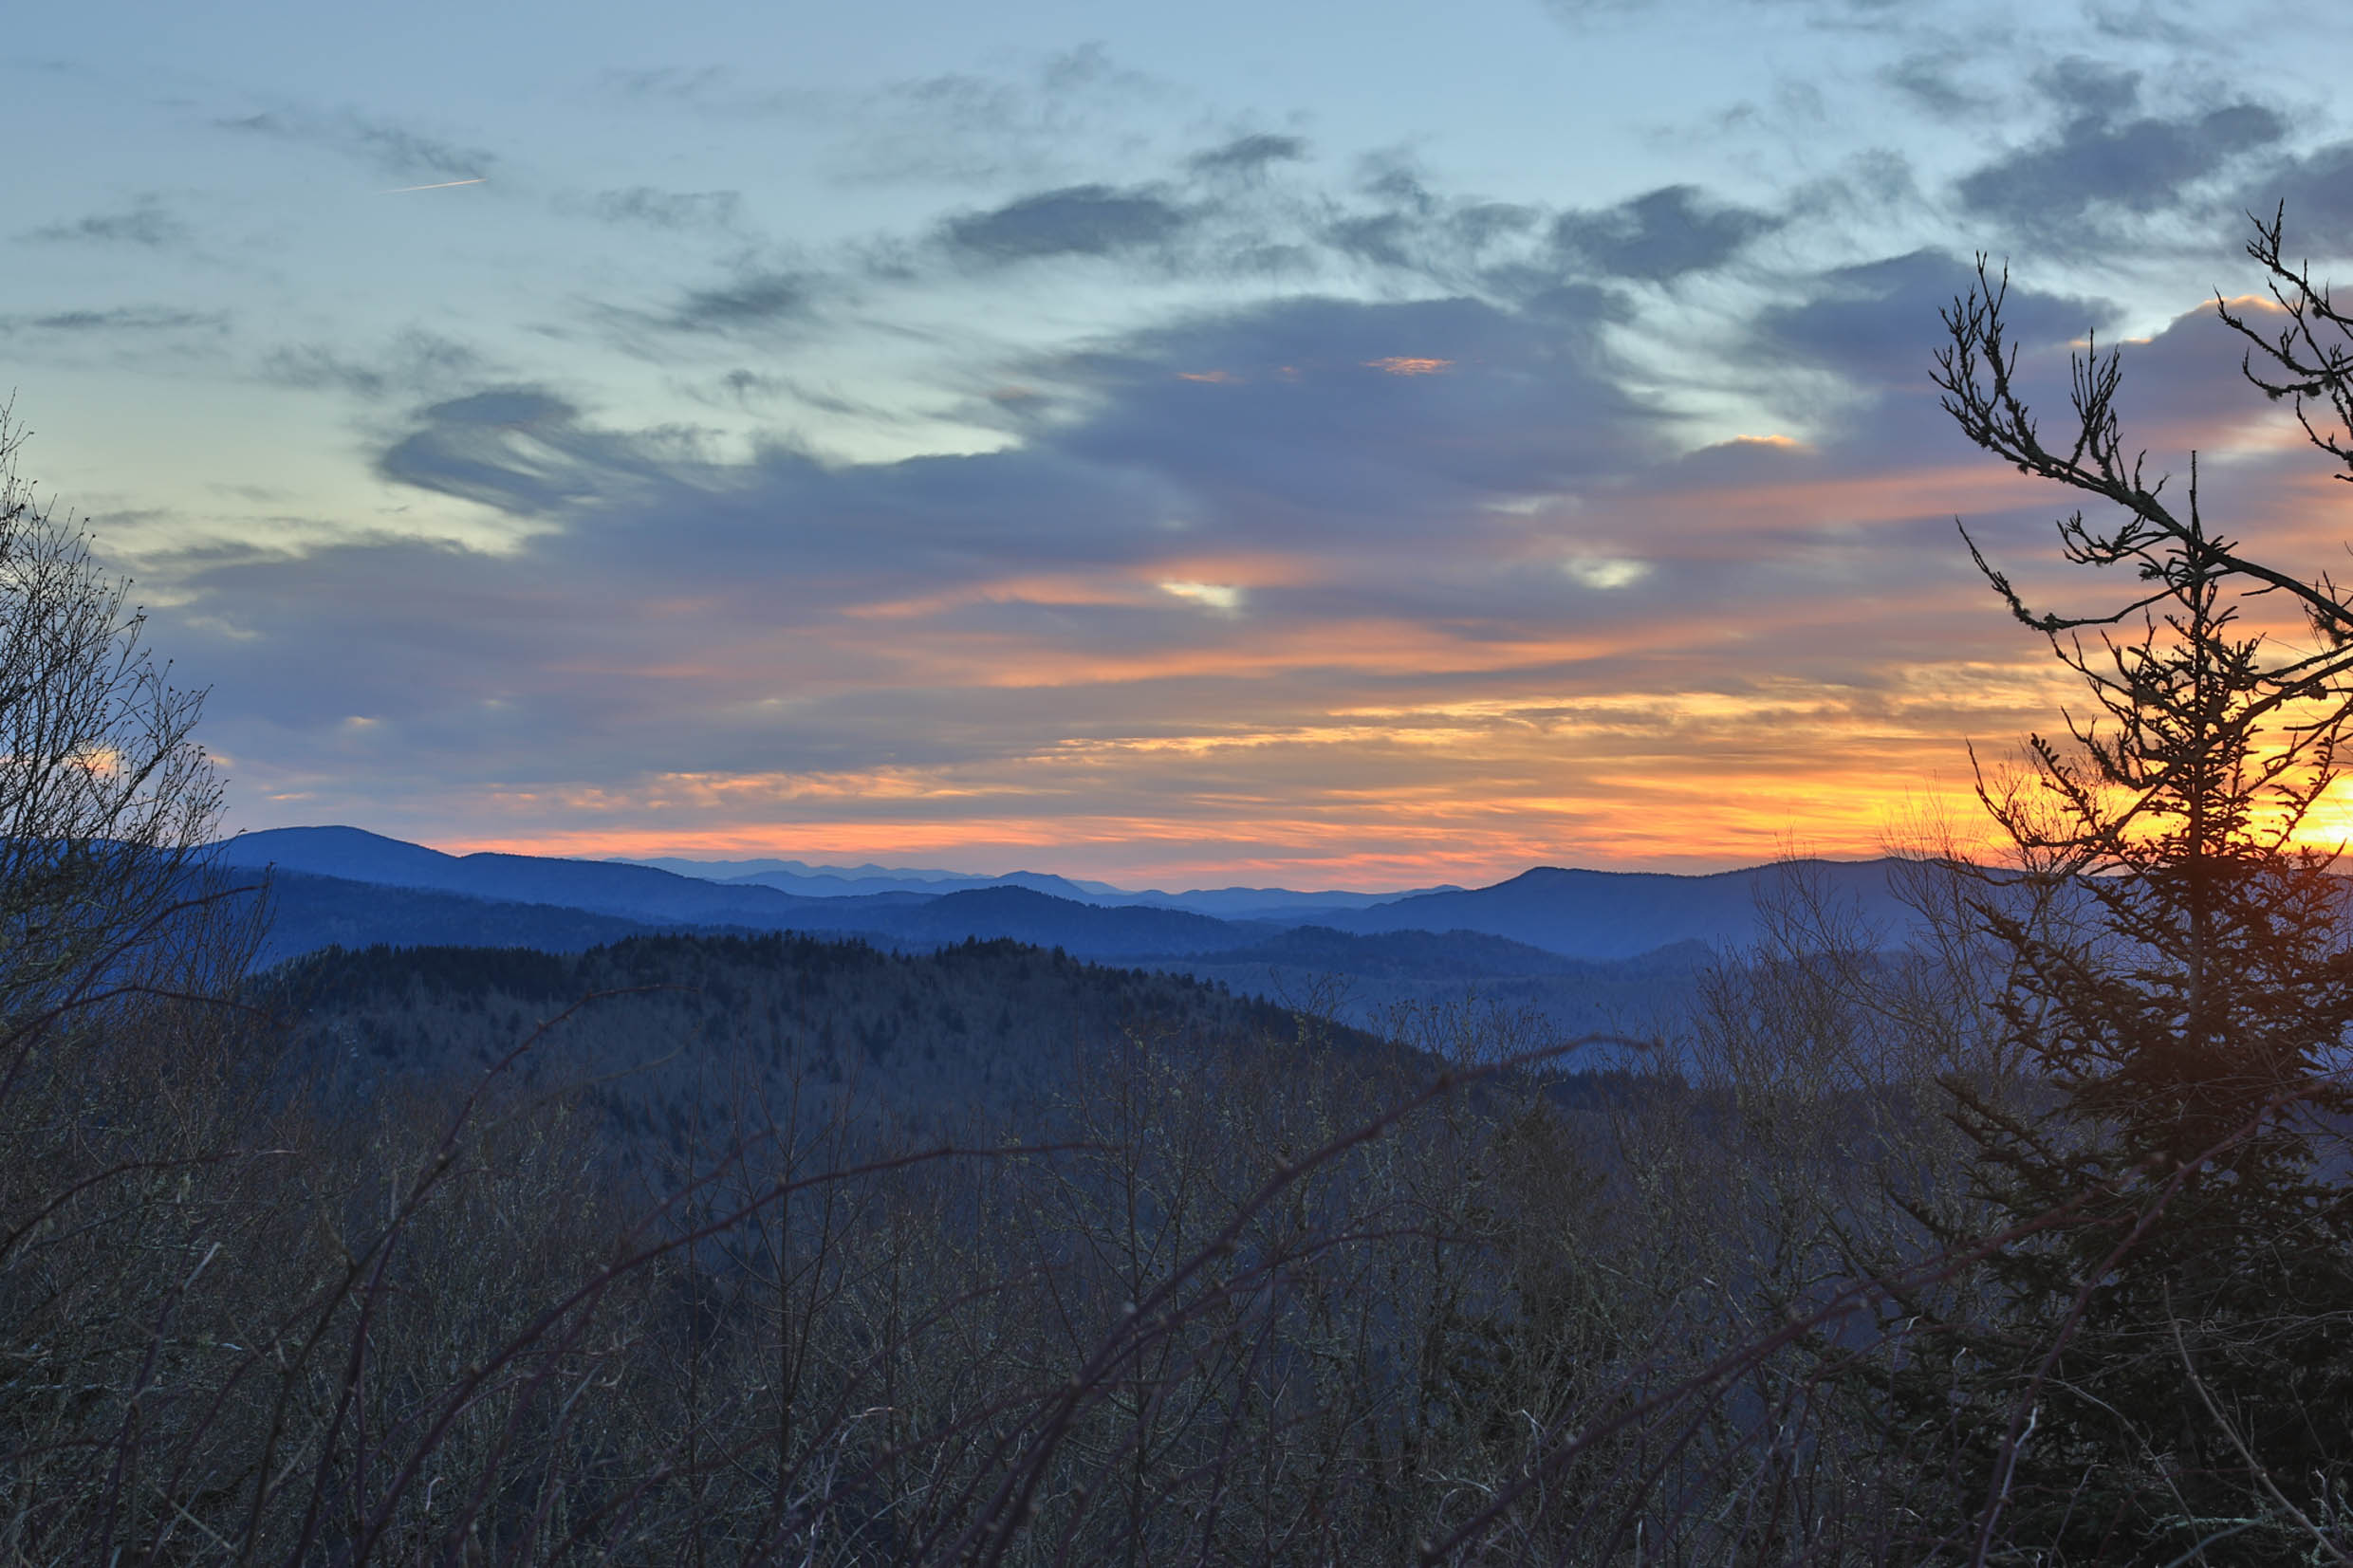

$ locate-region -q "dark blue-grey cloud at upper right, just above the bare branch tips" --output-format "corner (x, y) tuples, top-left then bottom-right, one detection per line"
(1960, 97), (2288, 247)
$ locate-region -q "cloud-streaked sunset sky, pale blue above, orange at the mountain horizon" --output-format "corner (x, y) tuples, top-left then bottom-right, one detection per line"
(0, 0), (2353, 889)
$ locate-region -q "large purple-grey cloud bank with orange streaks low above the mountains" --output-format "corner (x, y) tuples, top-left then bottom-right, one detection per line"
(157, 251), (2315, 879)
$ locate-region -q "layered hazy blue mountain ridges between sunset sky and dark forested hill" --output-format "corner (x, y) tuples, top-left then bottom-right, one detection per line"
(221, 827), (1913, 1029)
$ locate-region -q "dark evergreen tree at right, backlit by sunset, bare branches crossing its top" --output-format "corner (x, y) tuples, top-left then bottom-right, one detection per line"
(1899, 226), (2353, 1563)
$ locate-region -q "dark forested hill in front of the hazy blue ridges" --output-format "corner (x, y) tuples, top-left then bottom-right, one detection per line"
(261, 935), (1372, 1152)
